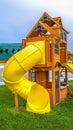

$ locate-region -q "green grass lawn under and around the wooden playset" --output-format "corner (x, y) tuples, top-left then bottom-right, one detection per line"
(0, 81), (73, 130)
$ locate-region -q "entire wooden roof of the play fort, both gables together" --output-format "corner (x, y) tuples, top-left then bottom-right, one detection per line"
(26, 12), (69, 38)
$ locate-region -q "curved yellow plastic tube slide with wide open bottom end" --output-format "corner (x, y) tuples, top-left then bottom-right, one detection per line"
(2, 43), (50, 114)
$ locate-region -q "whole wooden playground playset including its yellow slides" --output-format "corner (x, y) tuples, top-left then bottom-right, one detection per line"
(2, 12), (73, 113)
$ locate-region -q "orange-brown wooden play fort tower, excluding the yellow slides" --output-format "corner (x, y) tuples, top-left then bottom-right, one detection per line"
(22, 12), (69, 106)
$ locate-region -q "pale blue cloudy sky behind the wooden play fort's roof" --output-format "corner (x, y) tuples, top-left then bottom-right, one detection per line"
(0, 0), (73, 52)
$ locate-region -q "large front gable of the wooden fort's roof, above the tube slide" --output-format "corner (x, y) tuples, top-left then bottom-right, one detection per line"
(26, 12), (59, 38)
